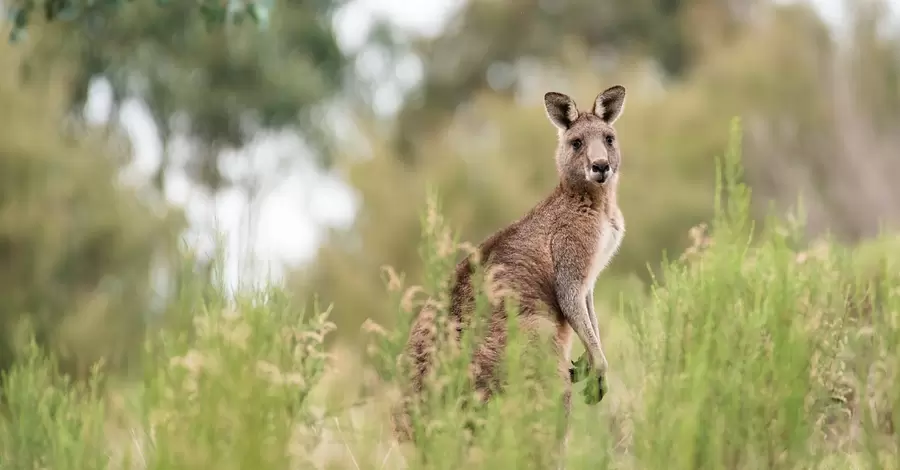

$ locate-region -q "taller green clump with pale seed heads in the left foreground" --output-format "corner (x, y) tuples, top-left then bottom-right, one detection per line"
(140, 288), (333, 469)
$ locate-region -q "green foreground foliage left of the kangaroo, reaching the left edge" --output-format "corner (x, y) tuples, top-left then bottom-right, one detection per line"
(0, 253), (333, 470)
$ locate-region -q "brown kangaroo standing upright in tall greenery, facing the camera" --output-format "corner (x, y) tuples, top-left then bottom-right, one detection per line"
(392, 85), (625, 454)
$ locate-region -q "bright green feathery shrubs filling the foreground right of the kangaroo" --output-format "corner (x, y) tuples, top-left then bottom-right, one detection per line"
(626, 119), (900, 468)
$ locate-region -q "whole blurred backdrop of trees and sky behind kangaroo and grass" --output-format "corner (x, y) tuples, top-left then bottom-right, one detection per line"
(0, 0), (900, 374)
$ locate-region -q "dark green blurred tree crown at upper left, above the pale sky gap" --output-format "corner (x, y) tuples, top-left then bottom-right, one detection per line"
(18, 0), (349, 190)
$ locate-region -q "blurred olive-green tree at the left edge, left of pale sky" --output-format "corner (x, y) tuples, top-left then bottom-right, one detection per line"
(0, 43), (182, 382)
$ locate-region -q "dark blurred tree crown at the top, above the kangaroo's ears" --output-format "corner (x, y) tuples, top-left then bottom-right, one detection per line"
(397, 0), (768, 162)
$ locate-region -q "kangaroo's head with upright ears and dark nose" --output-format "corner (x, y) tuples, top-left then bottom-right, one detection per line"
(544, 85), (625, 191)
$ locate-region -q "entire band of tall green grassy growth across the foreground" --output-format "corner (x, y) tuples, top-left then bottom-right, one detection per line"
(0, 119), (900, 470)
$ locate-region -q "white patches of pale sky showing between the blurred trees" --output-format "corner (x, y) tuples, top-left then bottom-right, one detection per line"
(86, 0), (884, 285)
